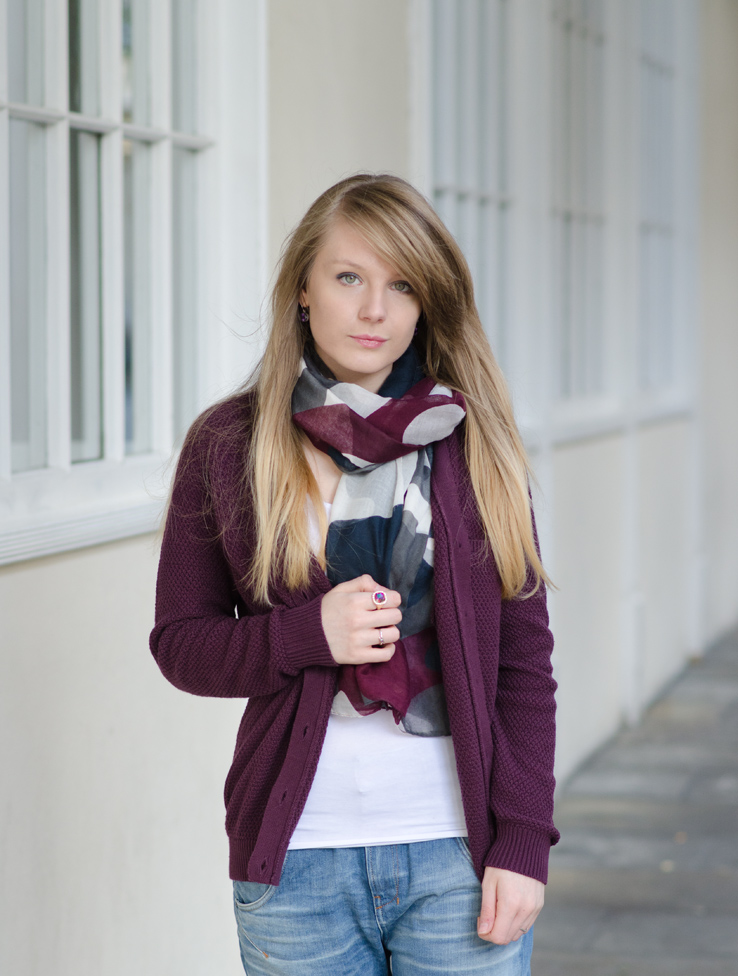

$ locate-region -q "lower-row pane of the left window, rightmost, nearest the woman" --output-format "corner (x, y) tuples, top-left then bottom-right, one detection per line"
(172, 149), (198, 436)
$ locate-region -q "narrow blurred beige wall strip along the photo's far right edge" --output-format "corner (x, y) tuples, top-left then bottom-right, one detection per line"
(700, 0), (738, 640)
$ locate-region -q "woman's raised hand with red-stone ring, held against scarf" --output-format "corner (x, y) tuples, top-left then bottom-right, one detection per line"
(321, 574), (402, 664)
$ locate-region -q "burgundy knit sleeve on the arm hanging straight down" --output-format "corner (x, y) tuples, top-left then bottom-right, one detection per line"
(484, 528), (559, 883)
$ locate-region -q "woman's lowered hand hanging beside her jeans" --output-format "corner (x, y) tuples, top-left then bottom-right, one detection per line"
(477, 868), (544, 945)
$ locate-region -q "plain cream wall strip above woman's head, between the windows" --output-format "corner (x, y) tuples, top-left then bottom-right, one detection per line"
(269, 0), (410, 263)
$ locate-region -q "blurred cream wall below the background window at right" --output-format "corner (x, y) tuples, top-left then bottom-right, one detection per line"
(548, 412), (695, 781)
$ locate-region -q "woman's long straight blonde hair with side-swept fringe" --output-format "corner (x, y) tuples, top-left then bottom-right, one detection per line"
(190, 174), (548, 604)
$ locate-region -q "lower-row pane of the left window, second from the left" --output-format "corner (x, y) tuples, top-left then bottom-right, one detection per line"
(69, 130), (102, 461)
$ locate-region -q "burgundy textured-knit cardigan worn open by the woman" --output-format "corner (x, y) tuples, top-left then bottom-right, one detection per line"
(150, 394), (559, 884)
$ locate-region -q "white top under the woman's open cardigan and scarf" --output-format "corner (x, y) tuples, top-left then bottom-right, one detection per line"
(289, 502), (467, 849)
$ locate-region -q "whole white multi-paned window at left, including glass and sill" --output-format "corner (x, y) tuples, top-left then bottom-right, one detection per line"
(0, 0), (263, 562)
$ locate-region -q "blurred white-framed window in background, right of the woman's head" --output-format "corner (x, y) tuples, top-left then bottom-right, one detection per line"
(426, 0), (698, 434)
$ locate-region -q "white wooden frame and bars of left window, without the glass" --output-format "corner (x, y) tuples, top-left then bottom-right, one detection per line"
(0, 0), (267, 564)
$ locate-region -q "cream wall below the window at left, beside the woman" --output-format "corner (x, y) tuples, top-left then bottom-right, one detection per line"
(0, 537), (242, 976)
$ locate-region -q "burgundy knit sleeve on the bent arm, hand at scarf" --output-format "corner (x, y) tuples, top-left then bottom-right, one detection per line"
(149, 408), (336, 698)
